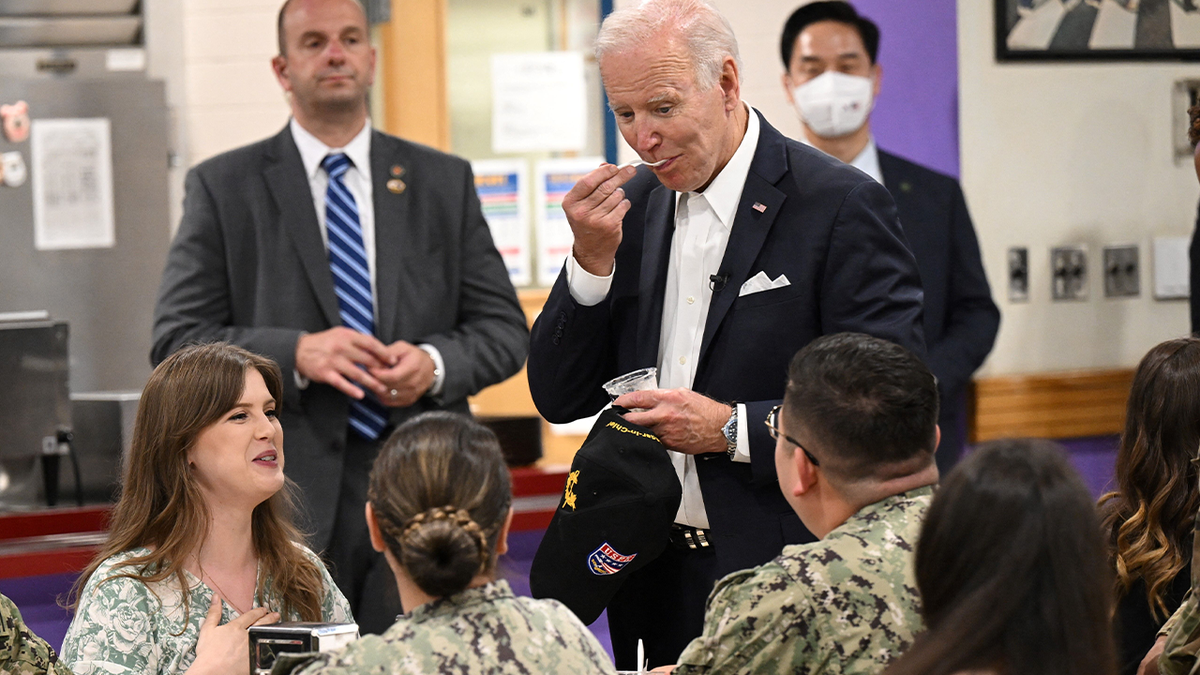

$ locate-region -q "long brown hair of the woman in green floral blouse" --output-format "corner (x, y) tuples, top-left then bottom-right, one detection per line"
(71, 342), (324, 623)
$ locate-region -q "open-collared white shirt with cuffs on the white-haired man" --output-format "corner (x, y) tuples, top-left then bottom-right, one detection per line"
(566, 106), (758, 528)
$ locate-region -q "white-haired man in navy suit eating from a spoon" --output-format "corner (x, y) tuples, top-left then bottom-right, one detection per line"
(529, 0), (924, 669)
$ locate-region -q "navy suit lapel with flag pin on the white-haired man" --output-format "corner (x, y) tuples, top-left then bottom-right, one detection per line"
(696, 115), (787, 367)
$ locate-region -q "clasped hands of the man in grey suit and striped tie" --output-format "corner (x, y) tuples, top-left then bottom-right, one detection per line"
(296, 325), (436, 407)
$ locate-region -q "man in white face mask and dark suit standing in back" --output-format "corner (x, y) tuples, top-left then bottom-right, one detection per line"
(780, 0), (1000, 476)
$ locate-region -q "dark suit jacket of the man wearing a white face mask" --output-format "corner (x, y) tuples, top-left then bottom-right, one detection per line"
(880, 150), (1000, 455)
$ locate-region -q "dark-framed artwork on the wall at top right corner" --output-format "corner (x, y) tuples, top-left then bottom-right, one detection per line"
(994, 0), (1200, 61)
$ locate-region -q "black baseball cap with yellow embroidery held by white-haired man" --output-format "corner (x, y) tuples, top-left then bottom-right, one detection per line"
(529, 407), (683, 623)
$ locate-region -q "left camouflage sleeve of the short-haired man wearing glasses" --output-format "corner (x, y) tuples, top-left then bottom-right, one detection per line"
(674, 563), (811, 675)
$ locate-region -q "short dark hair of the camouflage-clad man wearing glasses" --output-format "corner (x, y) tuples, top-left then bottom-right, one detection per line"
(784, 333), (937, 482)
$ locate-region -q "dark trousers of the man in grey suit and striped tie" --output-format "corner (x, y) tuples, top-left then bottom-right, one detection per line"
(325, 431), (403, 634)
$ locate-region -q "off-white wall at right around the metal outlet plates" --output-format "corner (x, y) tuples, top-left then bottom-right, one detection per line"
(958, 0), (1200, 375)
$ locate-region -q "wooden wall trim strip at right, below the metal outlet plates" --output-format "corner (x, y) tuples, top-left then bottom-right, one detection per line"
(968, 369), (1134, 442)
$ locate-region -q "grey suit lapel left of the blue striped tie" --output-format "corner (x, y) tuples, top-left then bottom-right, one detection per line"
(264, 127), (342, 325)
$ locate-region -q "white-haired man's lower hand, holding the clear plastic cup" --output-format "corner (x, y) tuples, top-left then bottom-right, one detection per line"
(613, 389), (733, 455)
